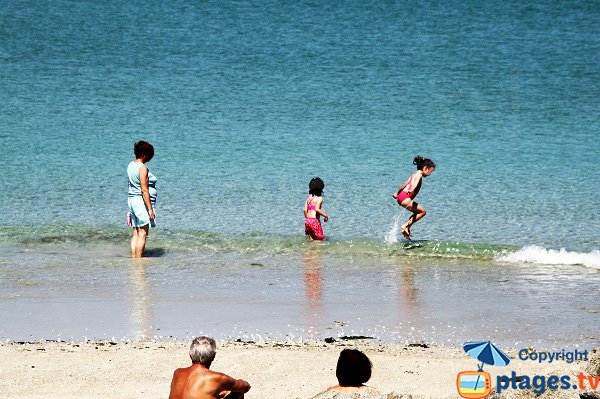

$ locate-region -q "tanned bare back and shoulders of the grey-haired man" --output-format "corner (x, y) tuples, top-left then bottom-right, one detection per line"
(169, 363), (250, 399)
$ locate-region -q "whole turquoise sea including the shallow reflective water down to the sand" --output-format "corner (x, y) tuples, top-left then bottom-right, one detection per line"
(0, 0), (600, 347)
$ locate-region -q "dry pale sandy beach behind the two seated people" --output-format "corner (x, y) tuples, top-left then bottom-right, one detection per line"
(0, 341), (589, 399)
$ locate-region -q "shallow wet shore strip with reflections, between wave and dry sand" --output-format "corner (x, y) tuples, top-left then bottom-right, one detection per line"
(0, 242), (599, 350)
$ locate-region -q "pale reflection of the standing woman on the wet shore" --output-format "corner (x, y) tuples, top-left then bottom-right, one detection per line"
(129, 259), (153, 338)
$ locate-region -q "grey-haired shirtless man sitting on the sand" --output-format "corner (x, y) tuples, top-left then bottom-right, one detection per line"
(169, 337), (250, 399)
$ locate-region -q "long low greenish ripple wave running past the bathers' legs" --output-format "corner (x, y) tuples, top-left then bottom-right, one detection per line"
(0, 223), (519, 260)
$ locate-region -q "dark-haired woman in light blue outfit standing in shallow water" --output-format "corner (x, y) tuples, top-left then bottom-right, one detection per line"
(127, 141), (156, 258)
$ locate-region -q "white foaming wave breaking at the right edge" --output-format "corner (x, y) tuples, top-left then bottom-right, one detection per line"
(496, 245), (600, 269)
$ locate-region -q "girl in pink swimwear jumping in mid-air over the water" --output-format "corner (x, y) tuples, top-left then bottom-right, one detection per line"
(392, 155), (435, 240)
